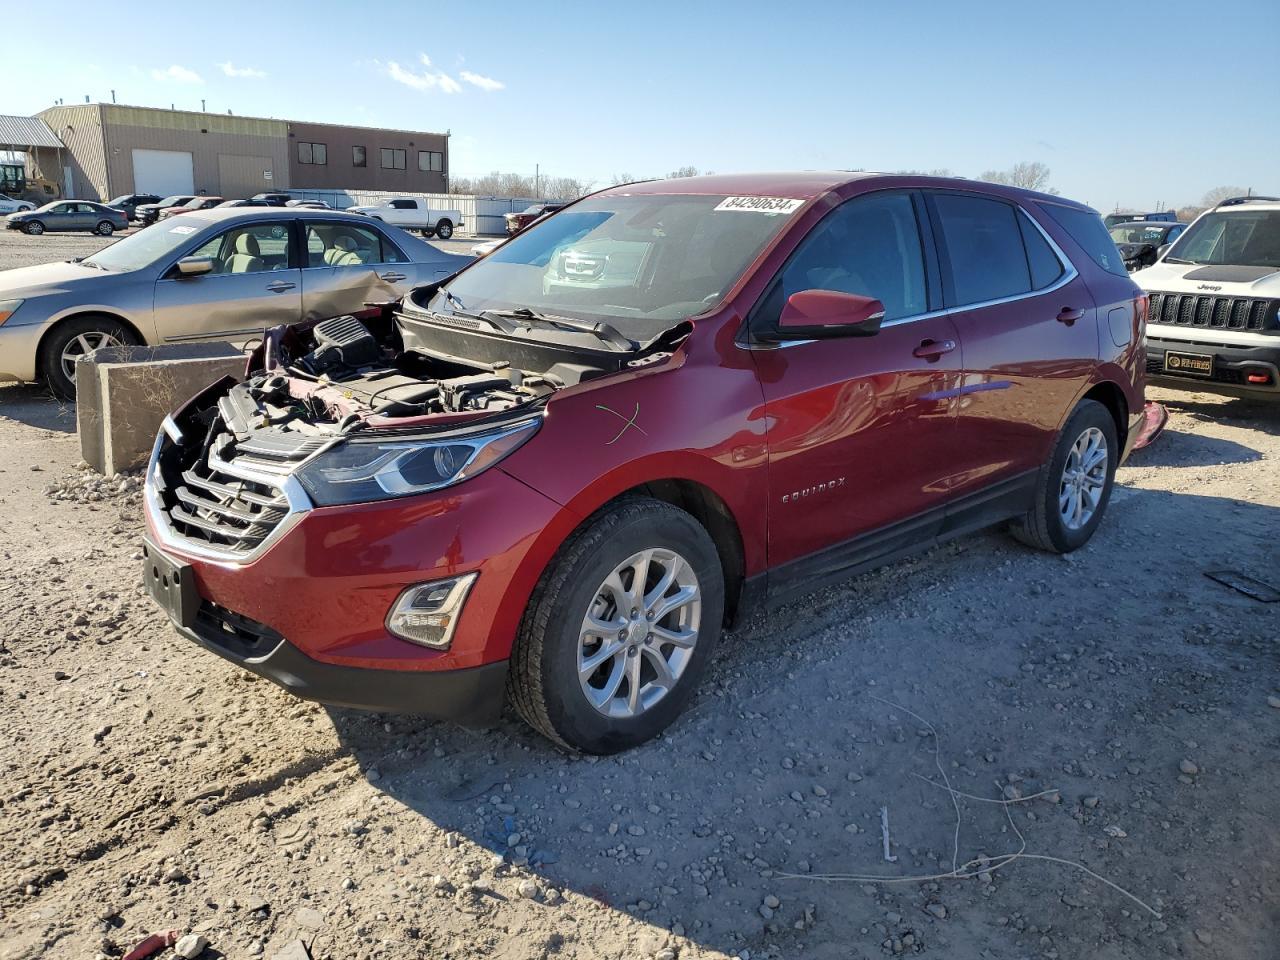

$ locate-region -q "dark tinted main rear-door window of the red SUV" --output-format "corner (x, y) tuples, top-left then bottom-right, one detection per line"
(933, 193), (1032, 306)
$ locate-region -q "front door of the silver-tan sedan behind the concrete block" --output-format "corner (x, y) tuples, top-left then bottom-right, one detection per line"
(155, 218), (302, 342)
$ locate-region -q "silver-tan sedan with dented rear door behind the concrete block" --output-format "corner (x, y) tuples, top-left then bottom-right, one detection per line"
(0, 207), (471, 398)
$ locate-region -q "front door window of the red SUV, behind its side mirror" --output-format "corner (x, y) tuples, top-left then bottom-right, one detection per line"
(753, 193), (928, 326)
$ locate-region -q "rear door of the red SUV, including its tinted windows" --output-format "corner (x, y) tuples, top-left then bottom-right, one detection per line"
(927, 191), (1098, 497)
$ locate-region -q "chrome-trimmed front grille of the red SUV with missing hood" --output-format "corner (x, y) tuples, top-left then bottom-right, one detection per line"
(164, 433), (289, 554)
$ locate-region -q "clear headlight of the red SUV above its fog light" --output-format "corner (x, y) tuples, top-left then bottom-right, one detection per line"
(297, 417), (541, 507)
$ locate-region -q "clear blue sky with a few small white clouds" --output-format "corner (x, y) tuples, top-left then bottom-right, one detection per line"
(12, 0), (1280, 210)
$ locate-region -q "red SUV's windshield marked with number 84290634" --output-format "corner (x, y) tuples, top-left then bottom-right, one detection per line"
(429, 195), (799, 342)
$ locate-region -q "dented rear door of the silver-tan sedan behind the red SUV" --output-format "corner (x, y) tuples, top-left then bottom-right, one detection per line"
(301, 219), (417, 320)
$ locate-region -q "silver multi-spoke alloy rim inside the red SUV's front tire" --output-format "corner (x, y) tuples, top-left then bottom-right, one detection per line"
(577, 547), (703, 718)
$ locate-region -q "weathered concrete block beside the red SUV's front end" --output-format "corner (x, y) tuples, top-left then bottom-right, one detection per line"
(76, 343), (244, 476)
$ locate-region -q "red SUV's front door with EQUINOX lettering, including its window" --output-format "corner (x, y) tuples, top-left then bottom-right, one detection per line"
(751, 192), (961, 576)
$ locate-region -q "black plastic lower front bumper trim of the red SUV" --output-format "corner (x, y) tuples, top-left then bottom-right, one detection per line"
(174, 611), (507, 726)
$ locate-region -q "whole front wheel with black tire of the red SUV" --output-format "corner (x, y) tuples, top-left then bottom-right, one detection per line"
(508, 498), (724, 754)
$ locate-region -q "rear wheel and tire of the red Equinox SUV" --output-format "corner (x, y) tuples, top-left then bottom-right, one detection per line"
(1010, 399), (1120, 553)
